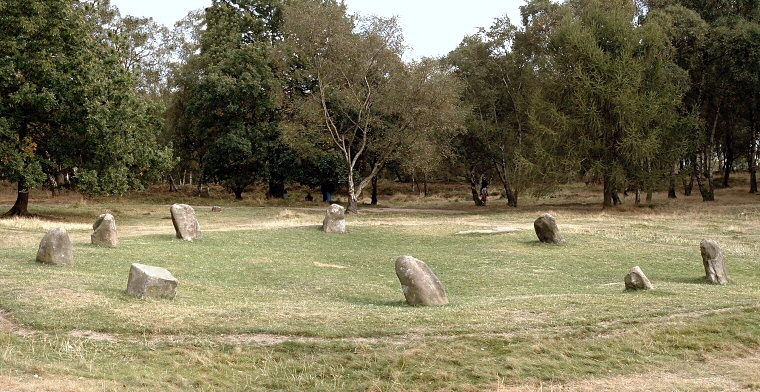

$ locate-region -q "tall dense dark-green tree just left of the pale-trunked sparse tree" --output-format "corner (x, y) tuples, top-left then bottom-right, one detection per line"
(172, 0), (287, 199)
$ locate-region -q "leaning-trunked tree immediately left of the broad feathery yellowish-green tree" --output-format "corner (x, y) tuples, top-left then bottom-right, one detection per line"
(448, 18), (559, 207)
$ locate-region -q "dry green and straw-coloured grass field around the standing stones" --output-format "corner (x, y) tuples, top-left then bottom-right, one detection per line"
(0, 180), (760, 391)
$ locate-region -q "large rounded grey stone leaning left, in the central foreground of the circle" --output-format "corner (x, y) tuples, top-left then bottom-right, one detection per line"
(396, 256), (449, 306)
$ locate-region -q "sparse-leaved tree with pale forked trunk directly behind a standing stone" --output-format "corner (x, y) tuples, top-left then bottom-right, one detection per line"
(283, 0), (456, 212)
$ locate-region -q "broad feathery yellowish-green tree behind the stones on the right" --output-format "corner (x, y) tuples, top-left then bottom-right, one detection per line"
(547, 0), (686, 207)
